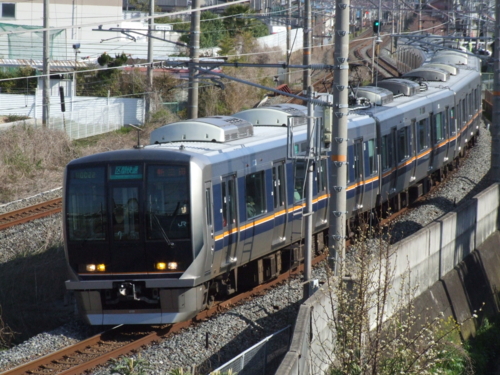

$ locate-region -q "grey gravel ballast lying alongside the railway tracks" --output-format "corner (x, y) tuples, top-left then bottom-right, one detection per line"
(0, 122), (492, 375)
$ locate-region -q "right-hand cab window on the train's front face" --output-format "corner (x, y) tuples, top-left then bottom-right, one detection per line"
(146, 165), (191, 241)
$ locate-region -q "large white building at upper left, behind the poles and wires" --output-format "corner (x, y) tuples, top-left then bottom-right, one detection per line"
(0, 0), (184, 60)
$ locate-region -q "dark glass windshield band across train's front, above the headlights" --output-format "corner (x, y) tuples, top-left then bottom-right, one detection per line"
(66, 162), (191, 243)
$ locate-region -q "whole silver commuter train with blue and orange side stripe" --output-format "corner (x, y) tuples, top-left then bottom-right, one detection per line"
(63, 51), (481, 325)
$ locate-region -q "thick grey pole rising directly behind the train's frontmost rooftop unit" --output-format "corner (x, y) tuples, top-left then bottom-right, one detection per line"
(188, 0), (200, 118)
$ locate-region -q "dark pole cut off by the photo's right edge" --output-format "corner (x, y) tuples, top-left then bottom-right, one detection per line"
(490, 0), (500, 182)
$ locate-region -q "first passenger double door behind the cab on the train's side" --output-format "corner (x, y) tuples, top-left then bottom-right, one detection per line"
(221, 175), (238, 267)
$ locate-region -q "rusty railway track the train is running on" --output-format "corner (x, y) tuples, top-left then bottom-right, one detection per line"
(1, 253), (326, 375)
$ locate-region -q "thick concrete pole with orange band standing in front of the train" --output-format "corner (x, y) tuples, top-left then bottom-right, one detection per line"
(329, 0), (350, 276)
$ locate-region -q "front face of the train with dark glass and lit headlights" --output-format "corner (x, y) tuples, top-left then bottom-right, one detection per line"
(64, 150), (206, 325)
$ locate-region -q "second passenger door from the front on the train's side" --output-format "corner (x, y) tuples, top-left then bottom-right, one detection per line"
(272, 160), (287, 246)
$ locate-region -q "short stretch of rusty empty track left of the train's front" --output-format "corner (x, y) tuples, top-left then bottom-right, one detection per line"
(0, 198), (62, 230)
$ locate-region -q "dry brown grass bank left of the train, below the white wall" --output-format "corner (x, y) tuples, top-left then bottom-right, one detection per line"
(0, 113), (181, 203)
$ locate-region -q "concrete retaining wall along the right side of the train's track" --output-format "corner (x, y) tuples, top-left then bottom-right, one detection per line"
(276, 184), (500, 375)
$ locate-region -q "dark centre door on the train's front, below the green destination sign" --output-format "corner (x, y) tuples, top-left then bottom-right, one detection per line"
(108, 180), (142, 272)
